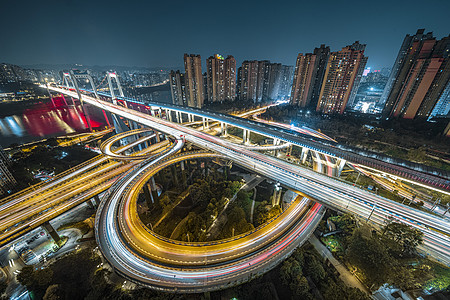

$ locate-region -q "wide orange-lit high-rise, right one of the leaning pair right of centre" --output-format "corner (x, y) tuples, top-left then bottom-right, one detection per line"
(316, 41), (367, 114)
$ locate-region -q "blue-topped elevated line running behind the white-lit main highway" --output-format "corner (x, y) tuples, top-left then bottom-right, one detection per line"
(83, 87), (450, 193)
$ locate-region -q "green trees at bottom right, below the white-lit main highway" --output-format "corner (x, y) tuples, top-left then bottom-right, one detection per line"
(321, 214), (450, 296)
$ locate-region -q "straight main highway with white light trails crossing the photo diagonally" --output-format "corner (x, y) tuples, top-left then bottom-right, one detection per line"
(51, 87), (450, 263)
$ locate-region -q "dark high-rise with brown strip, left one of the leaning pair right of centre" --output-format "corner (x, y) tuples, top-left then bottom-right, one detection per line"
(290, 45), (330, 109)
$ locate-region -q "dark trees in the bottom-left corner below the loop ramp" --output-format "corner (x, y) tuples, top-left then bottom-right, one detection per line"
(17, 249), (192, 300)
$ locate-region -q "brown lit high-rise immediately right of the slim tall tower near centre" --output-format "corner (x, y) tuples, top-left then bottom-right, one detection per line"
(206, 54), (236, 102)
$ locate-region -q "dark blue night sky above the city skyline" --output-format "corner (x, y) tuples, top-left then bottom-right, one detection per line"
(0, 0), (450, 69)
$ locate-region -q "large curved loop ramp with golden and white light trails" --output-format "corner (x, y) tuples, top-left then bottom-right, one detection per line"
(95, 151), (323, 292)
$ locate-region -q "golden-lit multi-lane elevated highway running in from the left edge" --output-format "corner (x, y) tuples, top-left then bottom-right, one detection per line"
(0, 133), (178, 247)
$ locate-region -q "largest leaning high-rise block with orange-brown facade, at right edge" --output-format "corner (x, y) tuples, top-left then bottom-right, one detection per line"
(383, 29), (450, 119)
